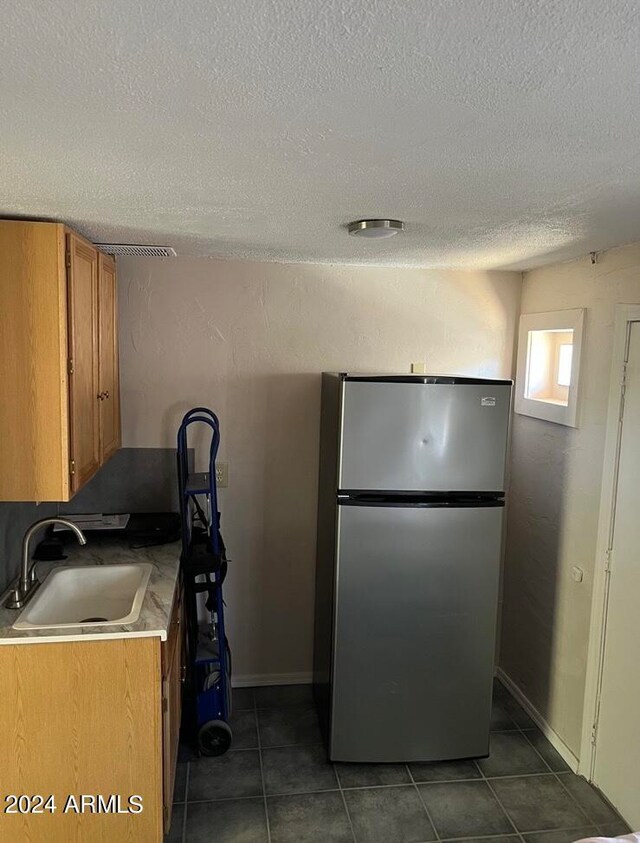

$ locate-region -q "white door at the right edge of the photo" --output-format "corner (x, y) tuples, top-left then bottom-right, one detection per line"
(593, 322), (640, 829)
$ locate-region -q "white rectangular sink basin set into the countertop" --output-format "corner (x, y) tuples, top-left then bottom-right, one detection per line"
(13, 562), (153, 629)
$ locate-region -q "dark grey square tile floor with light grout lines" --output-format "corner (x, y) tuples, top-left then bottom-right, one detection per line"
(167, 683), (629, 843)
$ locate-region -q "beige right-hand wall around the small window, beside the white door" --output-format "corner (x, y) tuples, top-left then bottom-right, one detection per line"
(500, 244), (640, 756)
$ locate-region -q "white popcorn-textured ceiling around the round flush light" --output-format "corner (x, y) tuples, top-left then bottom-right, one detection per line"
(0, 0), (640, 268)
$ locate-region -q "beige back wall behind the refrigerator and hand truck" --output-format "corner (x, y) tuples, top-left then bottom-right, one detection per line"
(119, 258), (521, 677)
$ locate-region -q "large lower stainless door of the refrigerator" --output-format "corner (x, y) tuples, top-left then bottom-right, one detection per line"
(329, 505), (504, 762)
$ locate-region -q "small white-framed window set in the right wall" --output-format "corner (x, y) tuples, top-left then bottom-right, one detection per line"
(515, 310), (584, 427)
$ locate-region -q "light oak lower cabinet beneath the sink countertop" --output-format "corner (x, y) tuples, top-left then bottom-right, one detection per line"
(0, 601), (182, 843)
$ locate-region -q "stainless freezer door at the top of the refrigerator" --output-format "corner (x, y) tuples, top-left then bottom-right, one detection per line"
(339, 380), (511, 492)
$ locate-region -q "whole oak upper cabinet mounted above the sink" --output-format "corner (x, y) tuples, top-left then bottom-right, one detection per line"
(0, 220), (120, 501)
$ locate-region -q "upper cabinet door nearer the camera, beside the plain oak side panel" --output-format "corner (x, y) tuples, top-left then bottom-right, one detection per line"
(67, 234), (100, 492)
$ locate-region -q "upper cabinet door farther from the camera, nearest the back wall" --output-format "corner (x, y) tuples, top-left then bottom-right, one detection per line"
(98, 254), (120, 464)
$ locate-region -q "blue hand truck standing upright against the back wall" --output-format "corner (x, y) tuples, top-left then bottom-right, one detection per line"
(177, 407), (232, 756)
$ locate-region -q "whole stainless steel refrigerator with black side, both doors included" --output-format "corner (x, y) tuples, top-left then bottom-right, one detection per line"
(314, 373), (511, 762)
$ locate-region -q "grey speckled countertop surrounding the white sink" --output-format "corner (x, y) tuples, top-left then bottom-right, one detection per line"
(0, 533), (180, 645)
